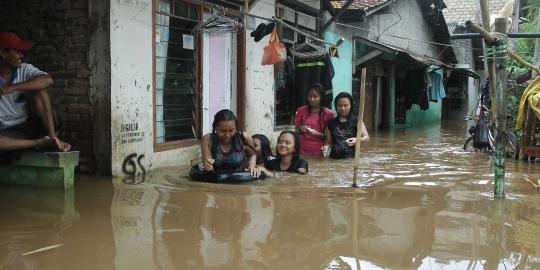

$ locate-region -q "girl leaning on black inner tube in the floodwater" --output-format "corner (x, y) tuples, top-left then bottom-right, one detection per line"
(199, 109), (261, 178)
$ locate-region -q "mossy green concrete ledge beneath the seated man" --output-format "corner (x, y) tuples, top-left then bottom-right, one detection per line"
(0, 151), (79, 189)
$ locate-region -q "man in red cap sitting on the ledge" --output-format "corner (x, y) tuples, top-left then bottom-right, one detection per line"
(0, 32), (71, 154)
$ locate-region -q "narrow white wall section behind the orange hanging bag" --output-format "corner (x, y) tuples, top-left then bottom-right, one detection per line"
(245, 0), (275, 138)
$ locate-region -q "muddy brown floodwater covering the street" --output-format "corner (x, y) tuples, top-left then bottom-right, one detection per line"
(0, 122), (540, 270)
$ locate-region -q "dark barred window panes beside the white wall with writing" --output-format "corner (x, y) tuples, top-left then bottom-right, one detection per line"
(154, 0), (201, 148)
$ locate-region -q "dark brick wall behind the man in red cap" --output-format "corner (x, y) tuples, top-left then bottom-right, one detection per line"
(0, 0), (95, 171)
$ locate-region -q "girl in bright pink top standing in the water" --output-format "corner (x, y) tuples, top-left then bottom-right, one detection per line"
(295, 83), (334, 156)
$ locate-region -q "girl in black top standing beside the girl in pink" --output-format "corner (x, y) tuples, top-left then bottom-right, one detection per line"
(321, 92), (369, 158)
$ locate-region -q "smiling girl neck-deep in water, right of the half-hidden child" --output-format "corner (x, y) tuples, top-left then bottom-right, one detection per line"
(262, 131), (308, 177)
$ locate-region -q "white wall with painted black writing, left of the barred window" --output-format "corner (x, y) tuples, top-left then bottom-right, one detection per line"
(110, 0), (199, 175)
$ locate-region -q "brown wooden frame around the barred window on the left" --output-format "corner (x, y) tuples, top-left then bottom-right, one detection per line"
(152, 0), (204, 152)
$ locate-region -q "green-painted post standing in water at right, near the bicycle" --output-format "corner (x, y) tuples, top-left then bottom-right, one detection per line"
(492, 18), (508, 198)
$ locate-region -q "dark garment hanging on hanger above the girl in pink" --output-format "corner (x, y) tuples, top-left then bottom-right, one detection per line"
(294, 54), (334, 108)
